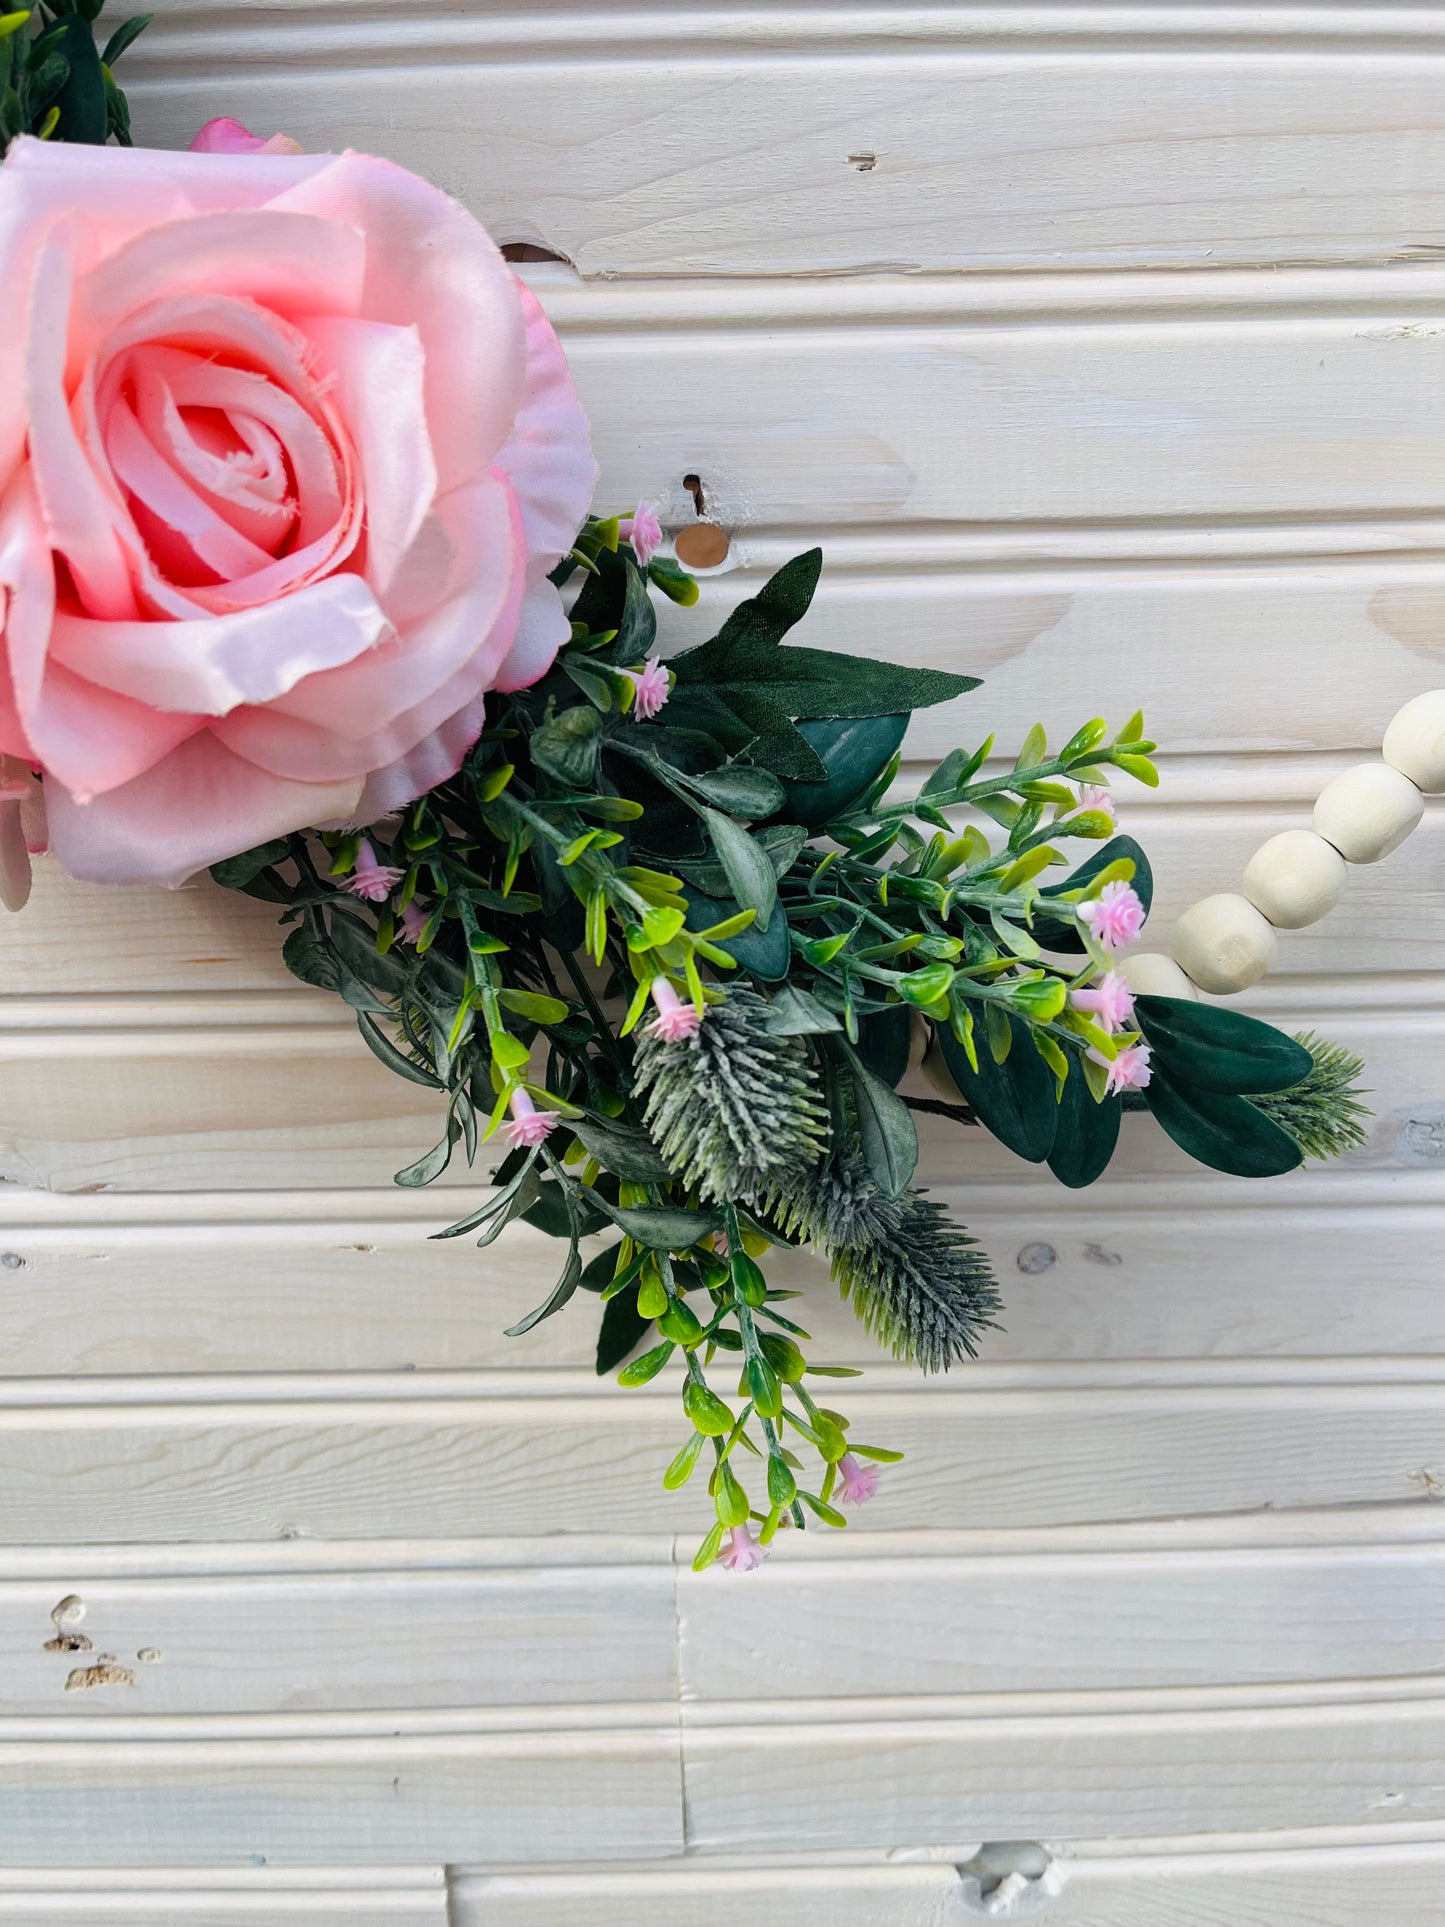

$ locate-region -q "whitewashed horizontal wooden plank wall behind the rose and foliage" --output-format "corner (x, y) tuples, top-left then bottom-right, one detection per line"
(0, 0), (1445, 1927)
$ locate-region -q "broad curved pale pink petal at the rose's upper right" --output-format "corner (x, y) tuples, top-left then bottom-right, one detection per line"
(276, 154), (526, 493)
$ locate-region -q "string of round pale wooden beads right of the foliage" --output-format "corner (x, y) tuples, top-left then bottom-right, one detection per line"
(1140, 690), (1445, 996)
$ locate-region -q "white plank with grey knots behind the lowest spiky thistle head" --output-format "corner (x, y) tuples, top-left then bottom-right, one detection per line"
(0, 1160), (1445, 1378)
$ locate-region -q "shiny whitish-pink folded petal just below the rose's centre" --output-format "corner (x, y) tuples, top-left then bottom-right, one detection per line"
(50, 574), (391, 717)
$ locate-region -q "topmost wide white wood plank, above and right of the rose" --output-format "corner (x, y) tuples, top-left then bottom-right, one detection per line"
(127, 15), (1445, 274)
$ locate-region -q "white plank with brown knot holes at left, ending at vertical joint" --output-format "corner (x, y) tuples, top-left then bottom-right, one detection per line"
(0, 1547), (676, 1718)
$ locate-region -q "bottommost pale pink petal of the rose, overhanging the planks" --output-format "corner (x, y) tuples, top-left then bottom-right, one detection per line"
(46, 730), (362, 886)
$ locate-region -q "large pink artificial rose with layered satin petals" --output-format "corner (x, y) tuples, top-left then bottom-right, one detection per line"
(0, 141), (595, 883)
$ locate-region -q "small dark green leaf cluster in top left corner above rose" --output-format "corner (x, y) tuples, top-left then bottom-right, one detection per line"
(0, 0), (152, 150)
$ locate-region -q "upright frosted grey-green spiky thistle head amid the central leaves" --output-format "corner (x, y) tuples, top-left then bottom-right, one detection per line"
(636, 987), (827, 1202)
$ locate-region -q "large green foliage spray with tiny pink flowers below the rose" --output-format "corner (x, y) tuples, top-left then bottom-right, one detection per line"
(214, 520), (1354, 1565)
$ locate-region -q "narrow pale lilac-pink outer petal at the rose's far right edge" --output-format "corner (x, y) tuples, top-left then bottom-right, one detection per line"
(497, 281), (597, 578)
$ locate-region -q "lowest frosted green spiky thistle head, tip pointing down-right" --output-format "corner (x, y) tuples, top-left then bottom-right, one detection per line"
(771, 1152), (1002, 1372)
